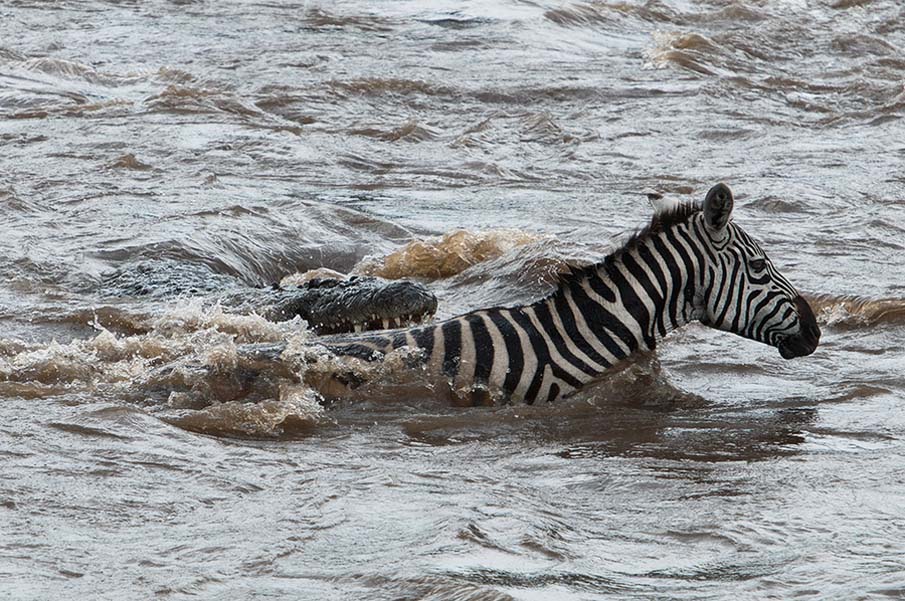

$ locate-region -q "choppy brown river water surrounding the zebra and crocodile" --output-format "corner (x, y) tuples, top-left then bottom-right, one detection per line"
(0, 0), (905, 600)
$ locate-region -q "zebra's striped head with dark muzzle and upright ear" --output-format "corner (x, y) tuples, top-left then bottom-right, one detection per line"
(648, 184), (820, 359)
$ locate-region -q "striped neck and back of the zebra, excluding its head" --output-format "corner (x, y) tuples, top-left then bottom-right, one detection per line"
(327, 213), (706, 403)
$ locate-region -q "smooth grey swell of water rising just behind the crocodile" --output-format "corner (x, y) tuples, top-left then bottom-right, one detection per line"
(81, 202), (411, 286)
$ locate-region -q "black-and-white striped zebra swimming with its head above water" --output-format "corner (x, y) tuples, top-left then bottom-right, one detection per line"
(290, 183), (820, 404)
